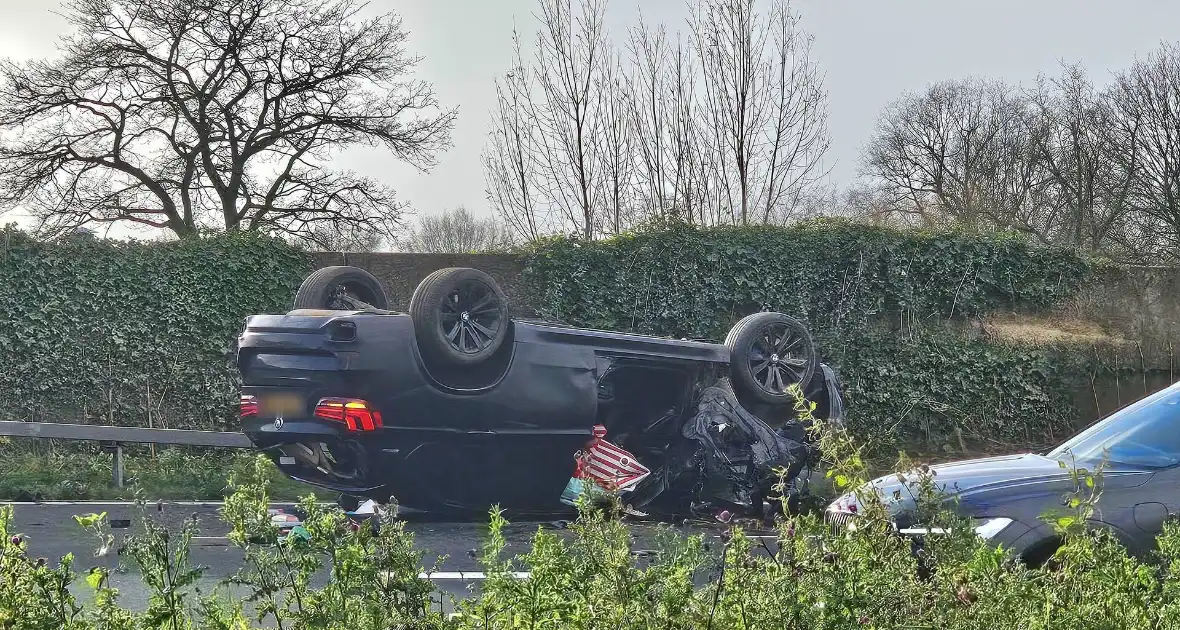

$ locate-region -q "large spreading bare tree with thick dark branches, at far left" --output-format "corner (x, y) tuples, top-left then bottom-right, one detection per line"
(0, 0), (455, 241)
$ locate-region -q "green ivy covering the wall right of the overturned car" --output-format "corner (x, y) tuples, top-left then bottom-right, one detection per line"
(526, 221), (1093, 453)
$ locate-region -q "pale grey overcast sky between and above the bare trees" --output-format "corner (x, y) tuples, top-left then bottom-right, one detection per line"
(0, 0), (1180, 233)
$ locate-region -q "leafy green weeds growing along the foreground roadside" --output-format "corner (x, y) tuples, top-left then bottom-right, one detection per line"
(0, 391), (1180, 630)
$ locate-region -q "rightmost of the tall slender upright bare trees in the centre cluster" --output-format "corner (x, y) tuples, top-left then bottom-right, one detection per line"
(693, 0), (830, 224)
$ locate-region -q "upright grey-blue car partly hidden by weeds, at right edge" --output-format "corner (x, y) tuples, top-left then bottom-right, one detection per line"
(826, 383), (1180, 565)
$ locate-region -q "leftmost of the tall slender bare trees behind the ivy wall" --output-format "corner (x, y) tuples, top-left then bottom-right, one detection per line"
(484, 0), (608, 238)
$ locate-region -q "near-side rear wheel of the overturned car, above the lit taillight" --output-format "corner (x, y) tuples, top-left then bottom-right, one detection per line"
(409, 267), (510, 366)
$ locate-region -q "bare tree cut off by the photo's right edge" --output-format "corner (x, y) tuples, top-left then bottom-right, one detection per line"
(1107, 44), (1180, 262)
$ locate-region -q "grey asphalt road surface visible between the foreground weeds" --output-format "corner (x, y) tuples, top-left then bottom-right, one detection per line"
(6, 503), (772, 610)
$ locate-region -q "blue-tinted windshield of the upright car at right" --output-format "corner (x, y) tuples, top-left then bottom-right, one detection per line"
(1049, 385), (1180, 468)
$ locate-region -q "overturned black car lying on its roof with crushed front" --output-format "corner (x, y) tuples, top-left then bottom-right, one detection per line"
(237, 267), (843, 514)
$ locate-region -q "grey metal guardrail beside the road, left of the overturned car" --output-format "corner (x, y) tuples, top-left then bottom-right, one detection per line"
(0, 421), (253, 487)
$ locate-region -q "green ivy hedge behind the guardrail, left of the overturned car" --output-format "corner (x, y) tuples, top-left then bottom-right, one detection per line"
(0, 228), (310, 428)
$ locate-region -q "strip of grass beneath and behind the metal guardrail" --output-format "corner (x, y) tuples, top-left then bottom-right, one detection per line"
(0, 442), (335, 501)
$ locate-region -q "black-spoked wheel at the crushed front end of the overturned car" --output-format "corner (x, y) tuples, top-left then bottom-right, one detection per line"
(726, 313), (819, 405)
